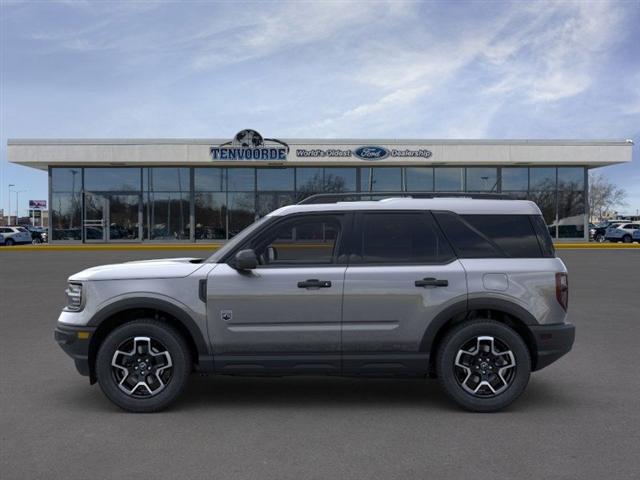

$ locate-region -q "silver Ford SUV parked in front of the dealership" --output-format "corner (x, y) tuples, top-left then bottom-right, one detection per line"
(55, 198), (574, 412)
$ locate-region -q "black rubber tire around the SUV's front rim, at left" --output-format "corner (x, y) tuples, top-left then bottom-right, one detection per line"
(96, 319), (192, 413)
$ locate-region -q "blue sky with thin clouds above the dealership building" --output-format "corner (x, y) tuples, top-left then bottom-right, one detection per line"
(0, 0), (640, 212)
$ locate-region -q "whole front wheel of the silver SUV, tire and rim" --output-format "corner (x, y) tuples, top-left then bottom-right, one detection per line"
(96, 319), (192, 412)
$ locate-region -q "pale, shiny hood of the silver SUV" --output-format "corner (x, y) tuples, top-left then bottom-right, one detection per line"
(69, 258), (202, 282)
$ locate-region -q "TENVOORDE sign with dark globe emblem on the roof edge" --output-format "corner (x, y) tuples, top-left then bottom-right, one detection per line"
(211, 130), (289, 161)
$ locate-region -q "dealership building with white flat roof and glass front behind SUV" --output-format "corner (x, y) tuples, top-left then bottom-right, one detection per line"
(8, 130), (633, 243)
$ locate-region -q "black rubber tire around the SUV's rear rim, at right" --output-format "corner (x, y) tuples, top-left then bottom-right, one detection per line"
(436, 319), (531, 412)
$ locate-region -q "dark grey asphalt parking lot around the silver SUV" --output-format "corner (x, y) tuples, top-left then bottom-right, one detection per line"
(0, 249), (640, 480)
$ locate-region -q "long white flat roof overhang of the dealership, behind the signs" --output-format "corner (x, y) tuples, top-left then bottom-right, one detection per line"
(8, 139), (633, 170)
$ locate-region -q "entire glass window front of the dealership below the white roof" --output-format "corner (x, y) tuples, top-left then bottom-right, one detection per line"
(50, 166), (586, 241)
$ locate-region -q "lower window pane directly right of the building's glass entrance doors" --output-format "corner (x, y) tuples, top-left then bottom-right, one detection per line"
(144, 192), (189, 240)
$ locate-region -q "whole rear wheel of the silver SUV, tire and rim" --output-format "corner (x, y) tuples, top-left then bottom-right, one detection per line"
(436, 319), (531, 412)
